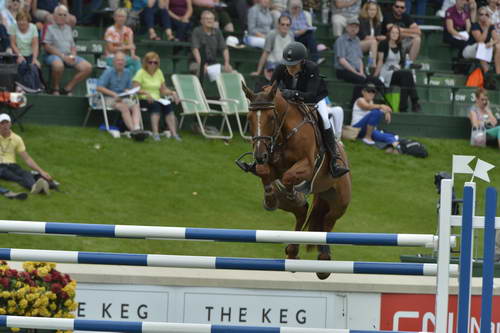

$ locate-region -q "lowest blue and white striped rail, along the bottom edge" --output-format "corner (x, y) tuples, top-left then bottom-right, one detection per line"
(0, 316), (422, 333)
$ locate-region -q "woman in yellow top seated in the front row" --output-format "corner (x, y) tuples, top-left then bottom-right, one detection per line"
(132, 52), (182, 141)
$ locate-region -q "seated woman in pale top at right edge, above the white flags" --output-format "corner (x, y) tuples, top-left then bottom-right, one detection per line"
(469, 88), (500, 148)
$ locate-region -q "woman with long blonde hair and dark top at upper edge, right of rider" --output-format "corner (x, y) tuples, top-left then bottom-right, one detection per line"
(358, 0), (385, 67)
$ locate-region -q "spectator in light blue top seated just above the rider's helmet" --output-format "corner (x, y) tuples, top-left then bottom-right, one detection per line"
(285, 0), (324, 63)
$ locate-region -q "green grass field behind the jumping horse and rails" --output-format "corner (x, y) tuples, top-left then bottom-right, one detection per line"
(0, 125), (500, 261)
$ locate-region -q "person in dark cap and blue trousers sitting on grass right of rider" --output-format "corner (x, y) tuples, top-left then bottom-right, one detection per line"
(351, 85), (399, 153)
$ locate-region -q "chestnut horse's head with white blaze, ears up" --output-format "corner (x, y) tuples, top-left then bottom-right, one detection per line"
(243, 82), (279, 164)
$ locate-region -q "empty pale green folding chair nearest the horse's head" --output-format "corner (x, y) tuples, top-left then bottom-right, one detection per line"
(217, 73), (252, 140)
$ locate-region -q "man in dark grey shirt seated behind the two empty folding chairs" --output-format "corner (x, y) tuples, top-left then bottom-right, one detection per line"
(189, 10), (233, 74)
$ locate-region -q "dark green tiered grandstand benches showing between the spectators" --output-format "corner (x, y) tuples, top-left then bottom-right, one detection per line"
(7, 1), (500, 138)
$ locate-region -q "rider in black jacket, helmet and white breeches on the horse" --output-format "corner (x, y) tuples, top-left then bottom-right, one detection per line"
(271, 42), (349, 178)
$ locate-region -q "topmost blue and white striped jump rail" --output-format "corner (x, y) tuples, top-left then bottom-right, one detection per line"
(0, 220), (456, 248)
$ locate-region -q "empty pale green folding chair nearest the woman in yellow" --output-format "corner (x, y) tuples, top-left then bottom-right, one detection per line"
(172, 74), (233, 140)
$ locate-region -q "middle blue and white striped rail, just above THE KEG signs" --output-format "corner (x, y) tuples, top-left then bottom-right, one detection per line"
(0, 248), (458, 276)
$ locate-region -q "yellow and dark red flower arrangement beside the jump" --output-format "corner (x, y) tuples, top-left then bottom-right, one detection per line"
(0, 260), (77, 333)
